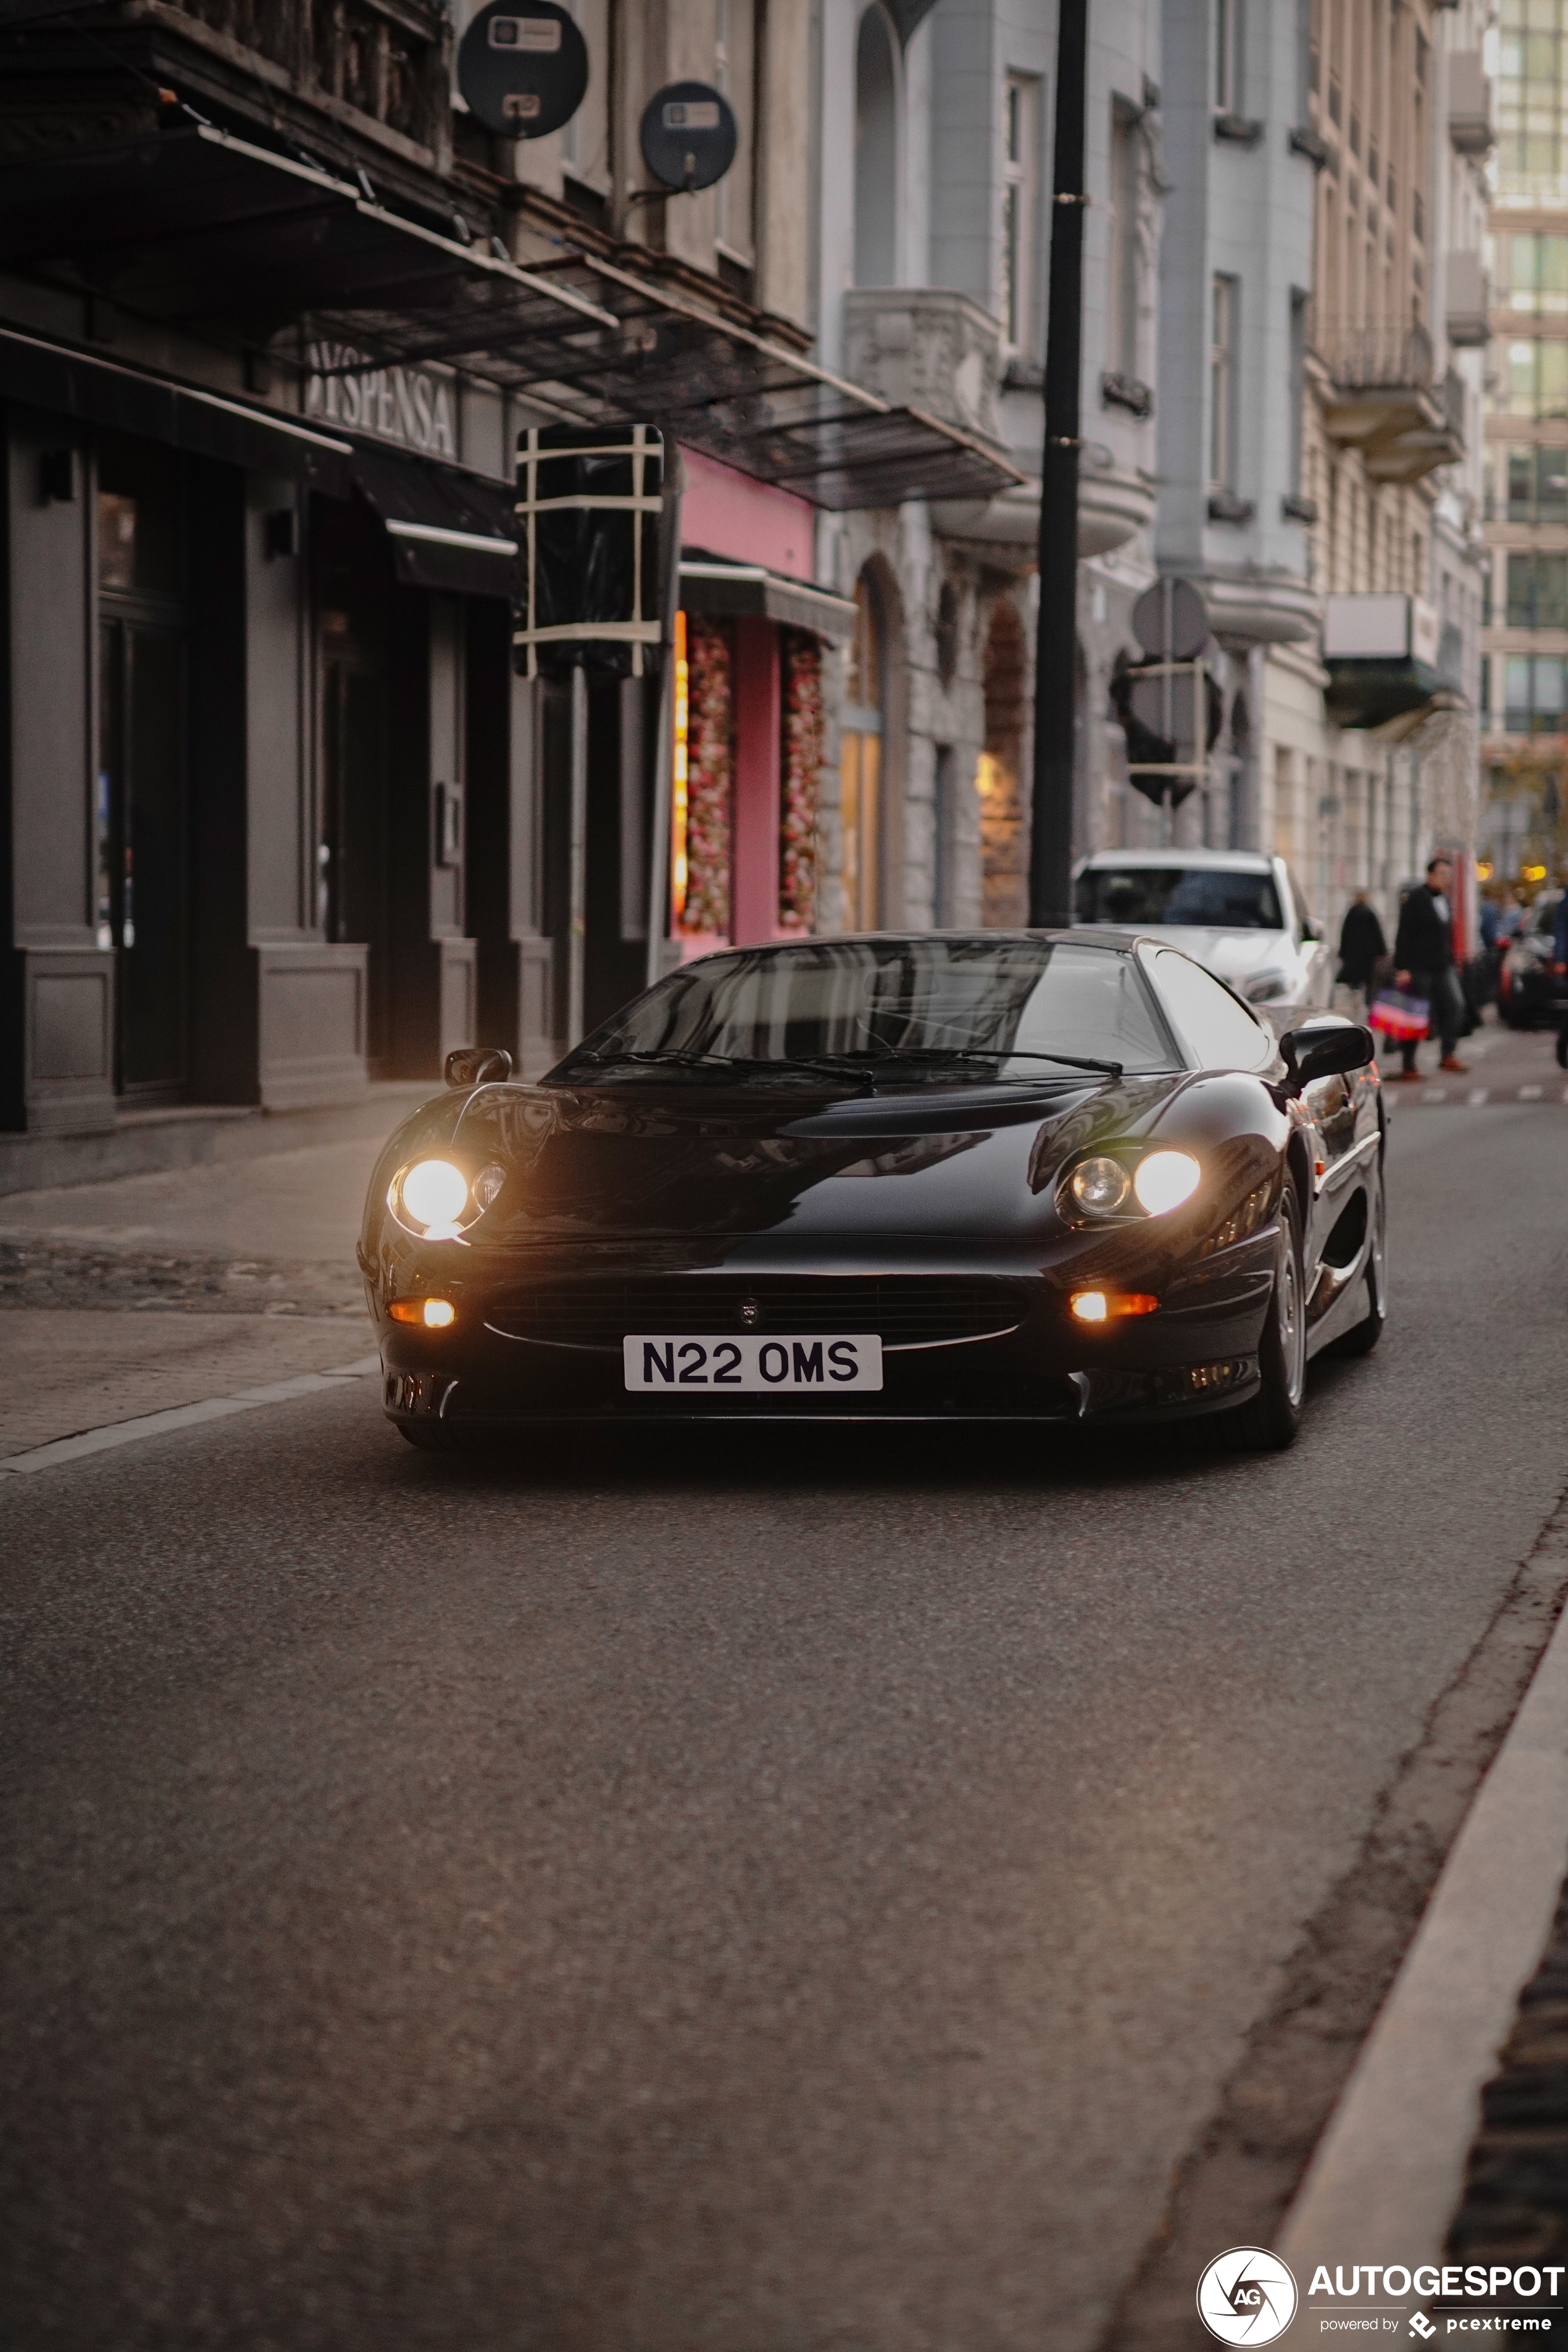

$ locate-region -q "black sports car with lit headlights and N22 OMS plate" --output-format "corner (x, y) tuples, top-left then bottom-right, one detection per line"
(360, 929), (1385, 1446)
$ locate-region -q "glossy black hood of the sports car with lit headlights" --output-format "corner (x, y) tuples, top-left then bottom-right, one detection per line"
(380, 1072), (1203, 1249)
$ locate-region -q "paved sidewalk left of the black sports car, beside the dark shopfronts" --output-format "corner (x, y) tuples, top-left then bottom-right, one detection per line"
(0, 1089), (423, 1461)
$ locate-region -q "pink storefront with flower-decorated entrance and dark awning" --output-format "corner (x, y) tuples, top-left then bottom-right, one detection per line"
(670, 449), (856, 957)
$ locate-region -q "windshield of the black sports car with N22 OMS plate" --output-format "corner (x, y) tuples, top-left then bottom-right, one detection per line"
(550, 936), (1178, 1086)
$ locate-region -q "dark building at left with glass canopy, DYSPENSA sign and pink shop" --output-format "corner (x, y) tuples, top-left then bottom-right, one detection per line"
(0, 0), (1013, 1133)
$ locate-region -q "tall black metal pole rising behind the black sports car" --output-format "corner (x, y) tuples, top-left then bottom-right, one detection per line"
(1030, 0), (1088, 927)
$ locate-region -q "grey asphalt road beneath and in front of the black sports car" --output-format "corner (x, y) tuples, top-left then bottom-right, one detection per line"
(0, 1103), (1568, 2352)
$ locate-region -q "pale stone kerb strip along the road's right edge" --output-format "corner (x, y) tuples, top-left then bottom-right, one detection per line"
(1274, 1524), (1568, 2277)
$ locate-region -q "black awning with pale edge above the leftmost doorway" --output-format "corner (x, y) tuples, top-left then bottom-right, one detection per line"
(0, 329), (352, 499)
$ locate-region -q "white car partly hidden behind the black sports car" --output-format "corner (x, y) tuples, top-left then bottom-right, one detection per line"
(1074, 849), (1335, 1028)
